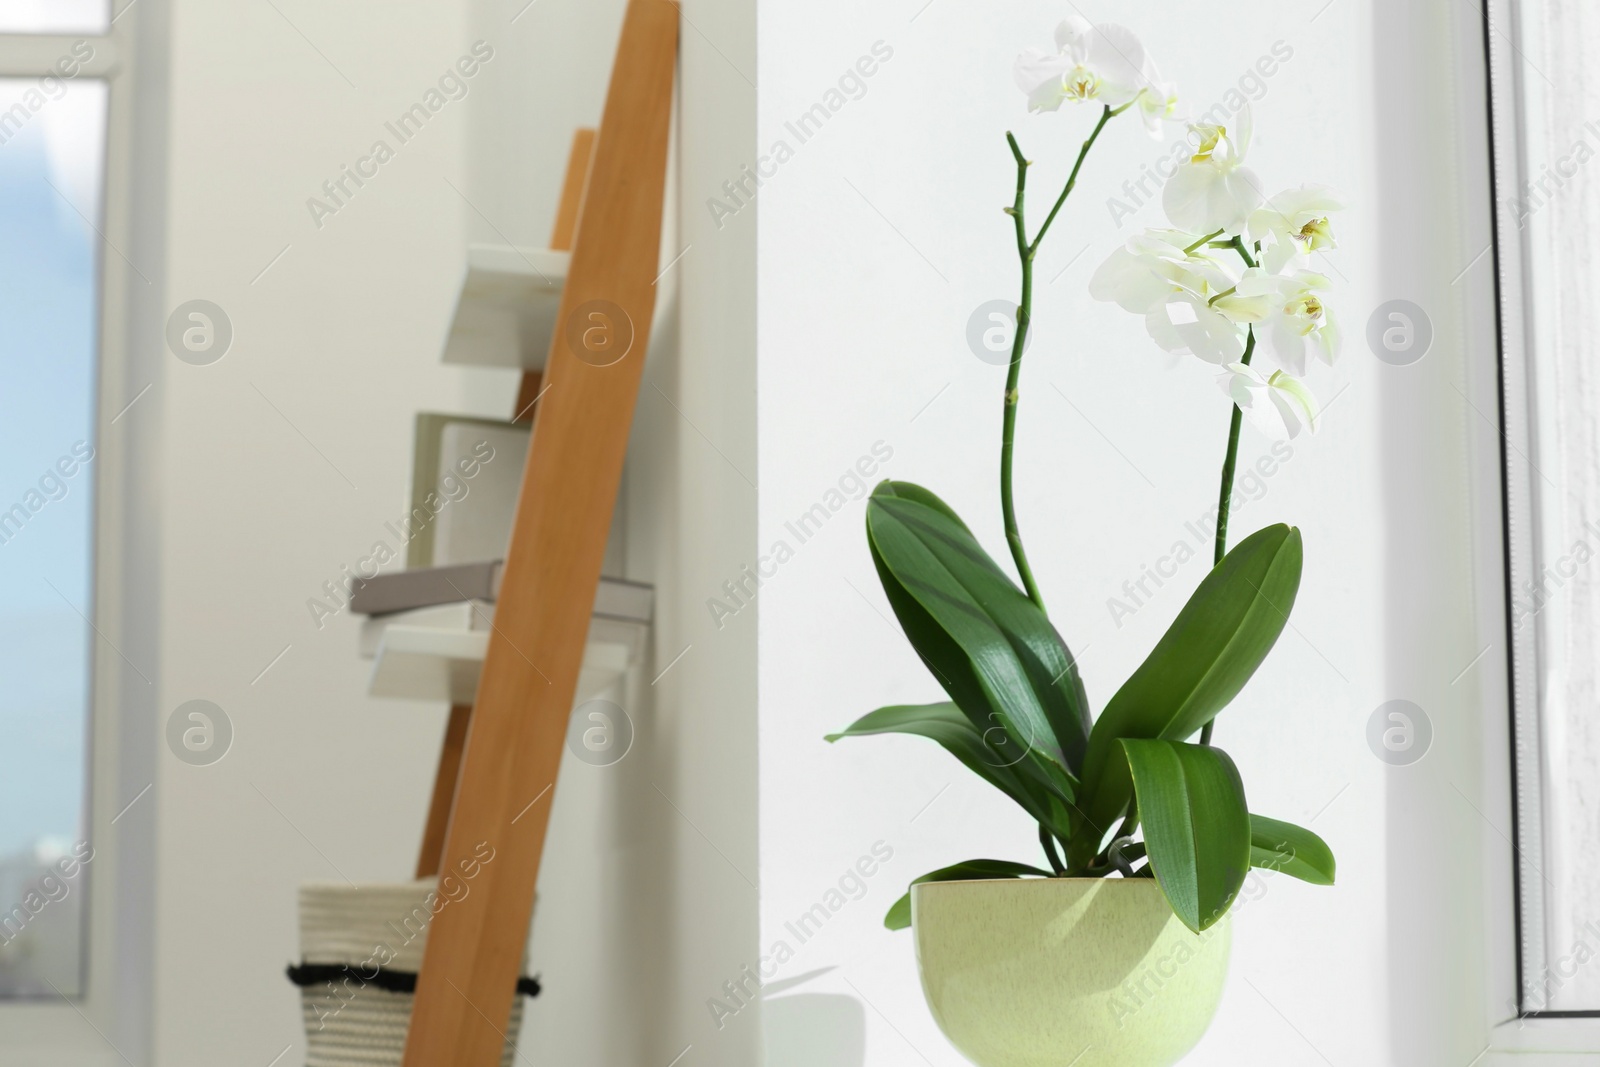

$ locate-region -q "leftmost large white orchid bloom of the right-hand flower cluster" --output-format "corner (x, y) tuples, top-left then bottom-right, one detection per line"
(1090, 230), (1270, 365)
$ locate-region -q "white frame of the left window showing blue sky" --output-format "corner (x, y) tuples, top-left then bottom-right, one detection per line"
(0, 0), (166, 1067)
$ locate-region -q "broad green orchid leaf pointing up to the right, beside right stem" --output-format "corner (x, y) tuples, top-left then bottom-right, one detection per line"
(1074, 525), (1302, 862)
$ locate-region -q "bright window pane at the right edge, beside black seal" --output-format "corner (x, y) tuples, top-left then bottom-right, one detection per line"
(1490, 0), (1600, 1016)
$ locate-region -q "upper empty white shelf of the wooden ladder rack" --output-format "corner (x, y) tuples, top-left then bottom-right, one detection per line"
(443, 245), (571, 371)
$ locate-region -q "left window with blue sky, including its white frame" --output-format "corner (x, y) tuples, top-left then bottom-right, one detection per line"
(0, 10), (132, 1036)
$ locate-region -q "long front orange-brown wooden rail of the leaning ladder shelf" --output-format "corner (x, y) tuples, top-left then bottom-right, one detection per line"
(403, 0), (678, 1067)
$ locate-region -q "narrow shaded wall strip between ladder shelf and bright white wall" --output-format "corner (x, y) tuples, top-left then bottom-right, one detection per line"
(614, 0), (760, 1067)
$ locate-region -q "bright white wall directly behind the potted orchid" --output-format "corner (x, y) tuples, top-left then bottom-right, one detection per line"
(755, 0), (1509, 1067)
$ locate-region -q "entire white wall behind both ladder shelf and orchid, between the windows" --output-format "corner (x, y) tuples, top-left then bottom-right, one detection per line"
(109, 0), (1509, 1067)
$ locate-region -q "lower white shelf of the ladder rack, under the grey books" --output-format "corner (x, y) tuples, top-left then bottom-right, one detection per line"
(362, 600), (650, 704)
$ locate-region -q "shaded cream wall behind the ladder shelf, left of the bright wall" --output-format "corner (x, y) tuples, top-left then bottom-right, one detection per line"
(144, 0), (757, 1067)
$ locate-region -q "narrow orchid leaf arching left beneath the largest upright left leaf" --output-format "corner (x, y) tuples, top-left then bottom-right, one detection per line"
(826, 701), (1077, 838)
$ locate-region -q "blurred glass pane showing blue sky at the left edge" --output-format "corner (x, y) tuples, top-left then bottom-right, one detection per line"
(0, 77), (104, 998)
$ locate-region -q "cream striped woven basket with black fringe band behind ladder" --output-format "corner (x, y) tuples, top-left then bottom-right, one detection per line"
(290, 878), (538, 1067)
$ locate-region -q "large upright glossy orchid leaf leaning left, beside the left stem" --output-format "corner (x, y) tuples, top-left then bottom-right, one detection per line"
(867, 482), (1090, 771)
